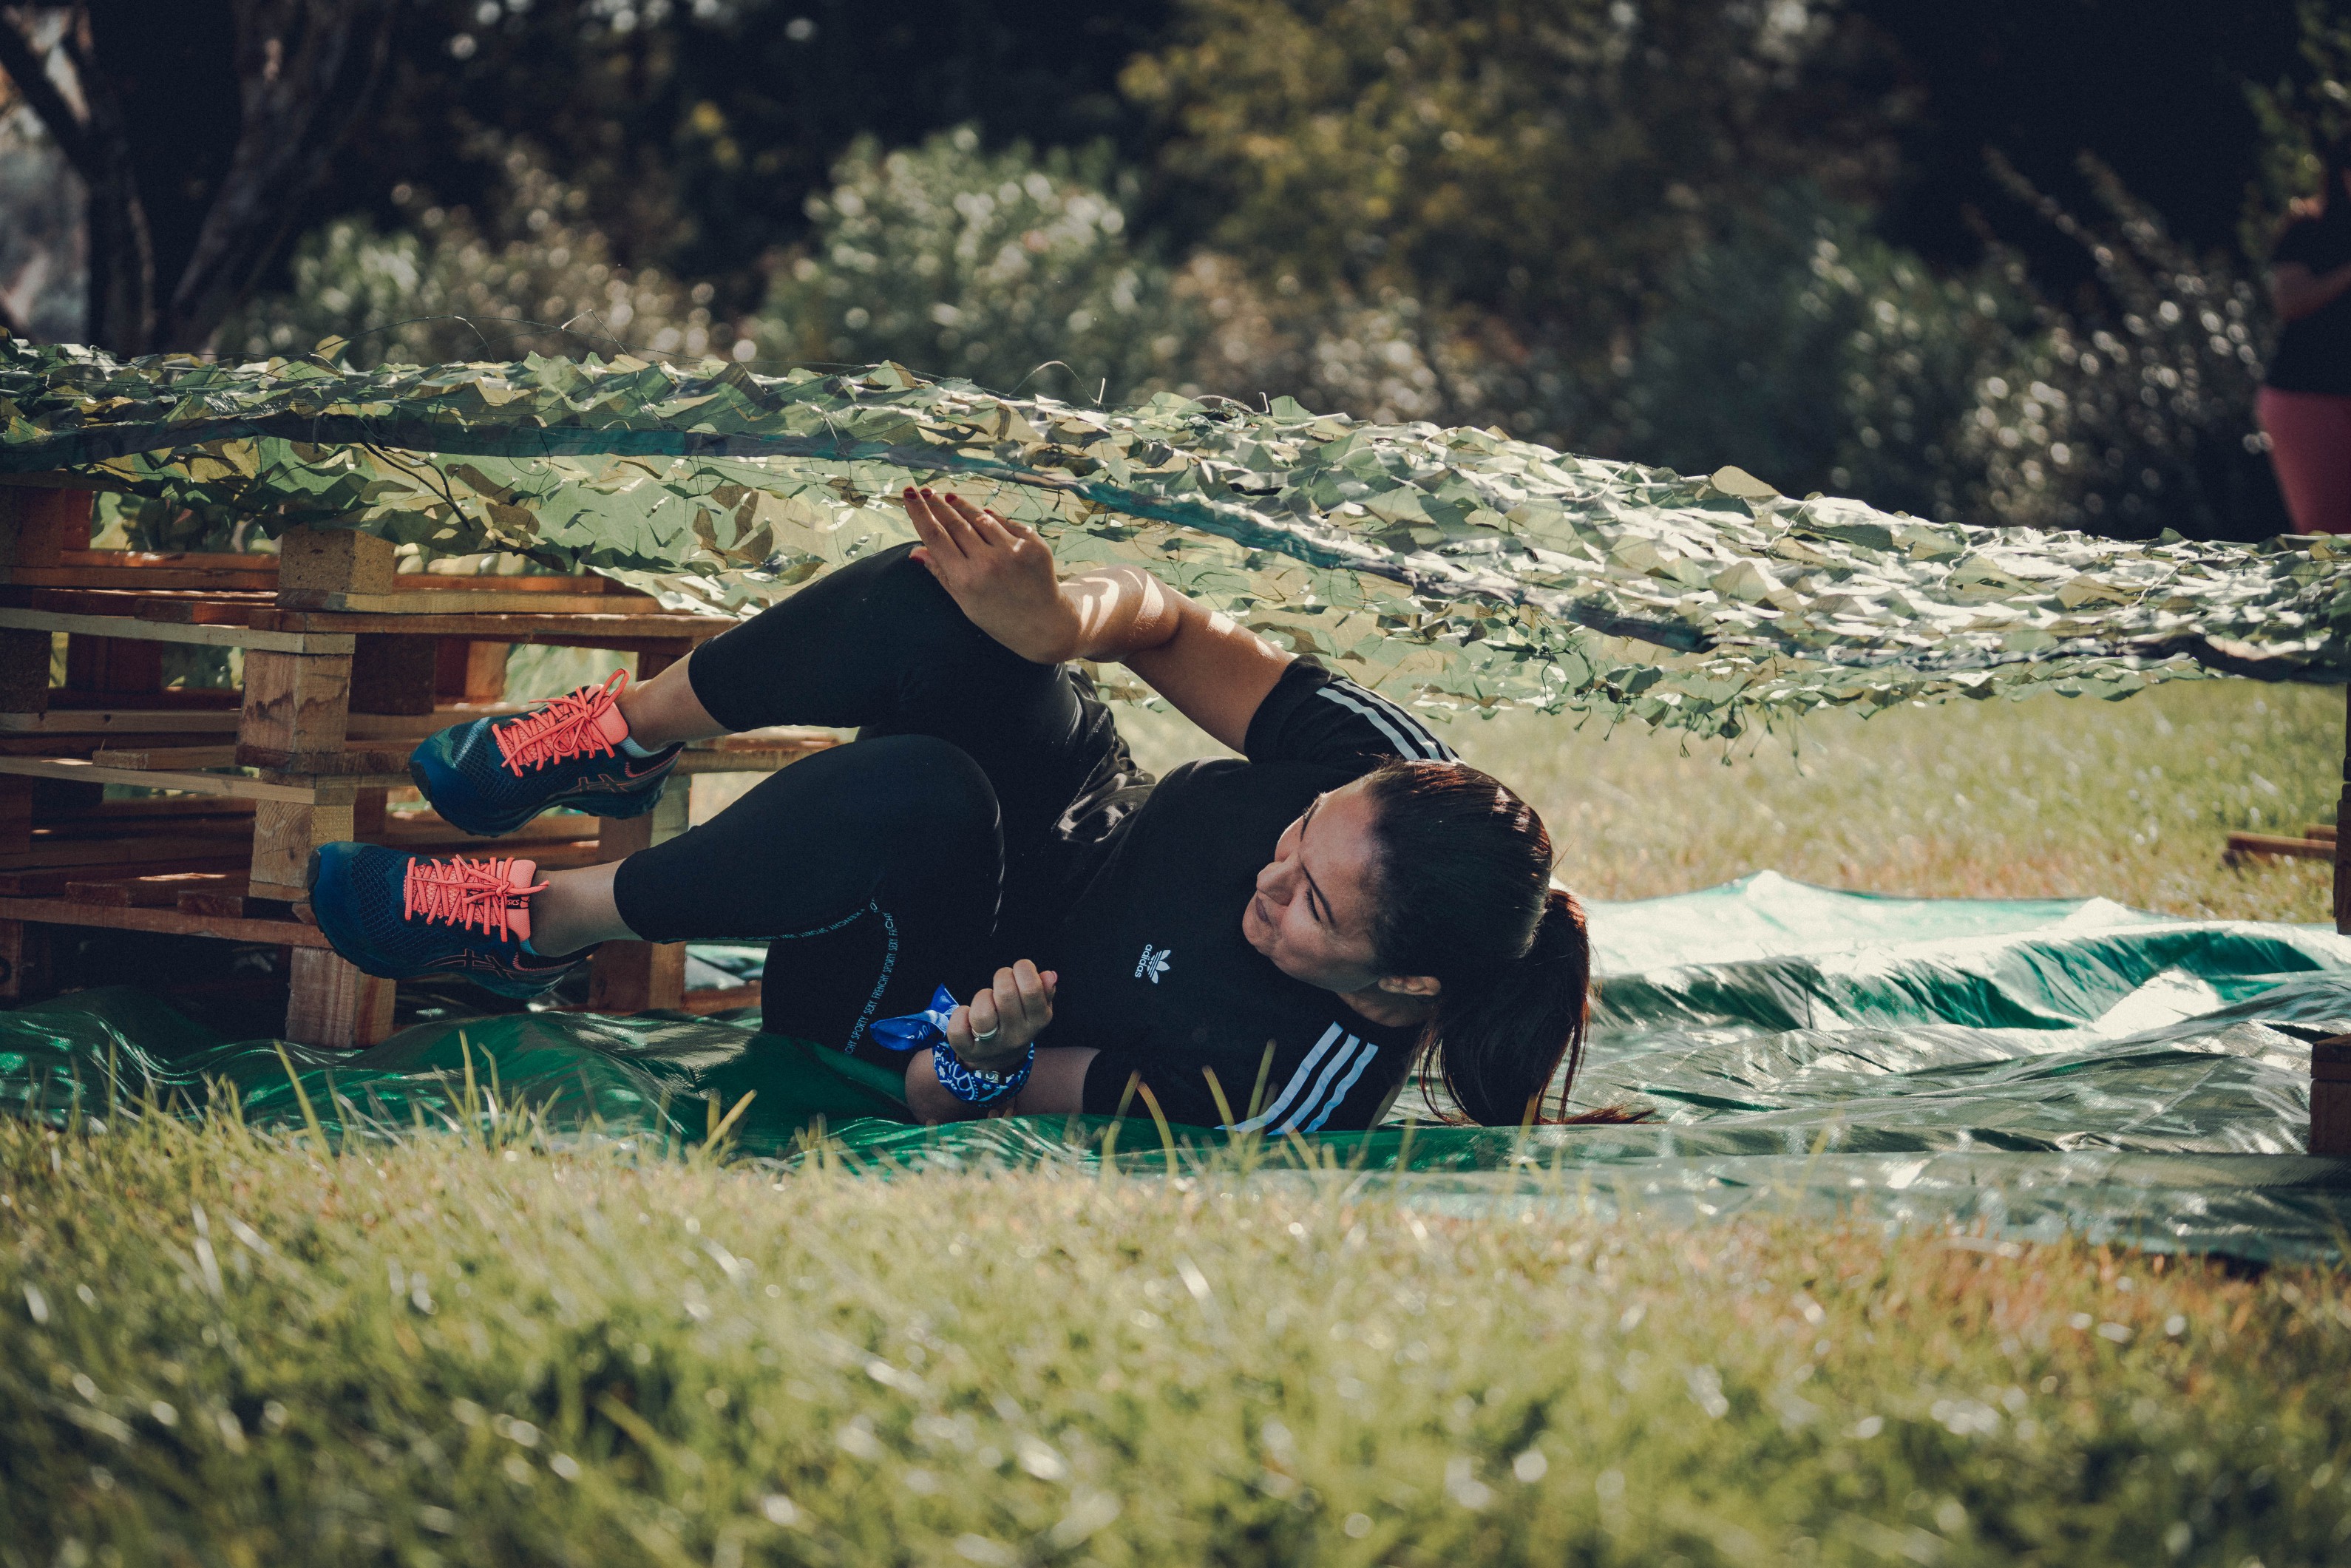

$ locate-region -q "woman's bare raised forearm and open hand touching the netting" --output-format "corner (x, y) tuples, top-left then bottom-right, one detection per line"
(905, 489), (1293, 750)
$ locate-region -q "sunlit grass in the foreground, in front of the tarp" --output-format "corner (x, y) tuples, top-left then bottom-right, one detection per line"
(0, 1121), (2351, 1568)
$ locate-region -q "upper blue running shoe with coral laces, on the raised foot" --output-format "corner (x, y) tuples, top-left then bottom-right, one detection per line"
(409, 670), (684, 837)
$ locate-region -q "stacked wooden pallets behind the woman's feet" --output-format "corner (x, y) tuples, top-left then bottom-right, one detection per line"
(0, 482), (832, 1046)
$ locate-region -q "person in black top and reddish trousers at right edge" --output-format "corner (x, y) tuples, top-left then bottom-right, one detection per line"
(2257, 136), (2351, 534)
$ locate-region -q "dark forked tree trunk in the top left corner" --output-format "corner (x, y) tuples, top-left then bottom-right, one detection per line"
(0, 0), (395, 353)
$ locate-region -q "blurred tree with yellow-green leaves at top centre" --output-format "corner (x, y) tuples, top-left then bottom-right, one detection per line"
(1126, 0), (1883, 371)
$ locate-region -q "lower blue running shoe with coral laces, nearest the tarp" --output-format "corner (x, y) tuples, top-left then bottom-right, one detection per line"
(311, 844), (588, 997)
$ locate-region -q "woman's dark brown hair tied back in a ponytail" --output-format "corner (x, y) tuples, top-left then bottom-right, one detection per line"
(1363, 761), (1592, 1126)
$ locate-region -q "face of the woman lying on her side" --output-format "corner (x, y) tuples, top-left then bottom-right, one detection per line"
(1241, 781), (1380, 994)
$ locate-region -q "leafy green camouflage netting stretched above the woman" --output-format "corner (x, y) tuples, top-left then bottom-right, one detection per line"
(0, 341), (2351, 736)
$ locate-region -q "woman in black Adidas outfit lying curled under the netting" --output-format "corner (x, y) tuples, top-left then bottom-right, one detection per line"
(311, 489), (1590, 1131)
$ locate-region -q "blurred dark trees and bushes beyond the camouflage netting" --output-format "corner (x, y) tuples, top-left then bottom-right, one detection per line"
(0, 0), (2351, 538)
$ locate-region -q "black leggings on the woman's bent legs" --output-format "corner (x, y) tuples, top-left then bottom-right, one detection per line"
(614, 546), (1150, 1060)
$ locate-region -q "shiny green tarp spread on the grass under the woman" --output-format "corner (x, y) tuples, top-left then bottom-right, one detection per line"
(0, 872), (2351, 1258)
